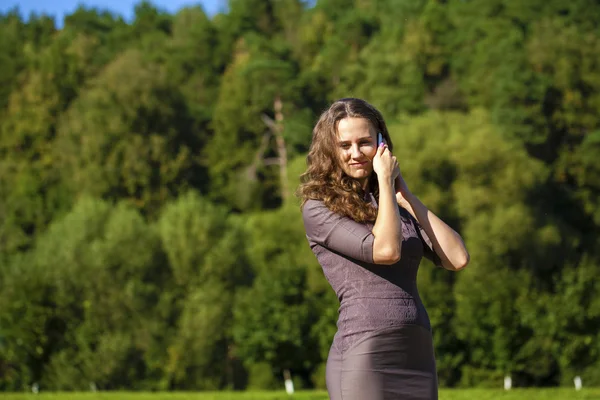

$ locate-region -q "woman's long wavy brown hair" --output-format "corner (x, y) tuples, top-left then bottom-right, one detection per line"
(297, 98), (393, 222)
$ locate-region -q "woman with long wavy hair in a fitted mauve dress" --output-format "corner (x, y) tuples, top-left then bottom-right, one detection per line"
(299, 98), (469, 400)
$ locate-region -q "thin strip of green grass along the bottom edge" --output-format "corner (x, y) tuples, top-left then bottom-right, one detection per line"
(0, 388), (600, 400)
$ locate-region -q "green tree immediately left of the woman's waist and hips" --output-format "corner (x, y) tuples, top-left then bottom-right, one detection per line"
(233, 206), (324, 385)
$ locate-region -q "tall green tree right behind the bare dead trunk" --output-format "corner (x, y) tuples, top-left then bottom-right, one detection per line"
(206, 32), (310, 210)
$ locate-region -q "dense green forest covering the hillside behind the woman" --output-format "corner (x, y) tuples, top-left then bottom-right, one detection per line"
(0, 0), (600, 391)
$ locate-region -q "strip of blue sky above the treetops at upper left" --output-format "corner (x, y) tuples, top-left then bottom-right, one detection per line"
(0, 0), (227, 26)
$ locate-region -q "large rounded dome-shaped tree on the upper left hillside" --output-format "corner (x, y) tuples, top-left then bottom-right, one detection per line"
(53, 50), (206, 214)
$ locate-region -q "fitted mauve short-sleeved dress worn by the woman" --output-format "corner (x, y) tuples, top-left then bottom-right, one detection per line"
(302, 195), (441, 400)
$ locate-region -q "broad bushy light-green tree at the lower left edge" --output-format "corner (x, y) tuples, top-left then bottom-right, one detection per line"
(1, 198), (169, 390)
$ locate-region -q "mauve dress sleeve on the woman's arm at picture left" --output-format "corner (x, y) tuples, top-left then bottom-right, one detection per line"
(302, 200), (374, 264)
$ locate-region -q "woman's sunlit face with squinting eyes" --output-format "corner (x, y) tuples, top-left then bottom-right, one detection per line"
(337, 117), (377, 187)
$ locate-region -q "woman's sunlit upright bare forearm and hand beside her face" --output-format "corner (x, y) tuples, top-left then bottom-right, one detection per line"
(373, 146), (402, 265)
